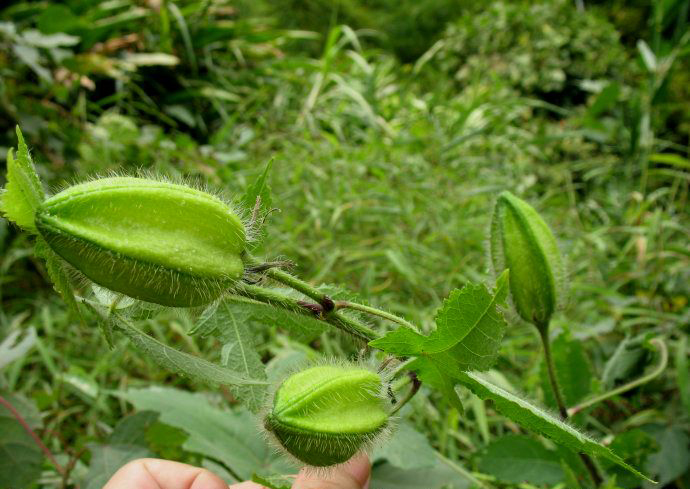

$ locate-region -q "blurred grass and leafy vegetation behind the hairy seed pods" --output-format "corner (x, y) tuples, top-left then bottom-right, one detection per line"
(0, 0), (690, 489)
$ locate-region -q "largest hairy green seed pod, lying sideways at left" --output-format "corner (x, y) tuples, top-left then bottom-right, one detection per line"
(35, 177), (245, 307)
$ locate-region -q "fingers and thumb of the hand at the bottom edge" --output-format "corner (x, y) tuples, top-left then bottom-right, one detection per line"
(103, 455), (371, 489)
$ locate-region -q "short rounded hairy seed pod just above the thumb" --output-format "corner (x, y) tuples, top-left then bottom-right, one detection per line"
(264, 366), (388, 467)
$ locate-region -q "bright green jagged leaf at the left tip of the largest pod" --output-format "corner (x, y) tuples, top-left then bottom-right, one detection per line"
(0, 126), (45, 233)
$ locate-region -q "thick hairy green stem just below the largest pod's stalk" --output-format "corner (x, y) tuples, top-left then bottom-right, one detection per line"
(235, 284), (381, 342)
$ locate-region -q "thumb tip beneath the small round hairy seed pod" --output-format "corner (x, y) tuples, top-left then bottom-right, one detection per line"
(292, 454), (371, 489)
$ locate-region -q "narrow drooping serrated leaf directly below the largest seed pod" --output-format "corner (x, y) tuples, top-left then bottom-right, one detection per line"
(113, 316), (267, 386)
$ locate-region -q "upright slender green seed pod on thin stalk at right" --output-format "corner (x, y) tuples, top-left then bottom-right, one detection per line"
(491, 192), (564, 328)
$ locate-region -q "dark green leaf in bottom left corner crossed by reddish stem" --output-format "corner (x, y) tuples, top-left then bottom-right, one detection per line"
(0, 393), (43, 488)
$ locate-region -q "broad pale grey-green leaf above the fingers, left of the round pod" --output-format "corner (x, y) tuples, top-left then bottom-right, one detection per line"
(118, 387), (295, 480)
